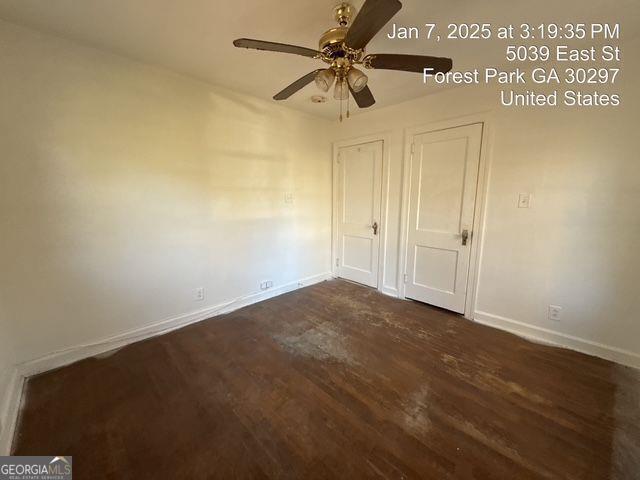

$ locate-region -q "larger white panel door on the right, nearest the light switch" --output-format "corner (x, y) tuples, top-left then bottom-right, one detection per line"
(405, 124), (482, 313)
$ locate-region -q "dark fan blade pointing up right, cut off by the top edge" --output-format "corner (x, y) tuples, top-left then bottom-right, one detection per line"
(344, 0), (402, 50)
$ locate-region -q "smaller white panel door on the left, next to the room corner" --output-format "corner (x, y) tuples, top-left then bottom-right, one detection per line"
(336, 141), (383, 287)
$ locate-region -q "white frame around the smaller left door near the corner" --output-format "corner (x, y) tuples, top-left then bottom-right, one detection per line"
(331, 132), (396, 296)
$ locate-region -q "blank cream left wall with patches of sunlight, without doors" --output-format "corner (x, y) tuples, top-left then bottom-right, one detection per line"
(0, 18), (331, 362)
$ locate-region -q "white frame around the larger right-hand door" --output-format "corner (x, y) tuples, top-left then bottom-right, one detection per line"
(398, 110), (494, 320)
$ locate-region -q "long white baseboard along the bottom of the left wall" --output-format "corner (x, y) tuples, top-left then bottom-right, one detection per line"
(18, 273), (331, 377)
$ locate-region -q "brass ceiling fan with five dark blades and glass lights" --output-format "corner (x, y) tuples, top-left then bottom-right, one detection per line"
(233, 0), (453, 121)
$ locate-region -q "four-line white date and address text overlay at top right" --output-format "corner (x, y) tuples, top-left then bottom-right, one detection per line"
(387, 23), (622, 107)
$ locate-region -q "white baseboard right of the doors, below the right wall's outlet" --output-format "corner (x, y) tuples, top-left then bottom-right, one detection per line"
(474, 311), (640, 368)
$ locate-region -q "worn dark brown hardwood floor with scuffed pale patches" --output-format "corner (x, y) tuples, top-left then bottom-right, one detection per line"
(14, 280), (640, 480)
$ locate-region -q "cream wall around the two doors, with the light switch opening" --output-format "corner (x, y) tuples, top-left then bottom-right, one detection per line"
(333, 42), (640, 366)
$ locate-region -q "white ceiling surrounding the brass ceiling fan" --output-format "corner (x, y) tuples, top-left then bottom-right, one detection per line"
(0, 0), (640, 118)
